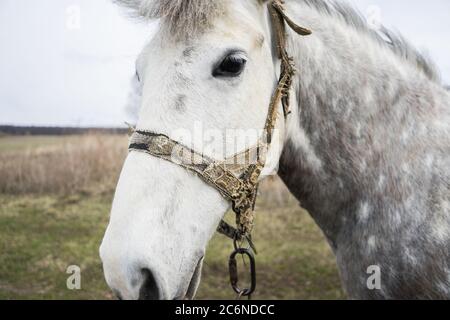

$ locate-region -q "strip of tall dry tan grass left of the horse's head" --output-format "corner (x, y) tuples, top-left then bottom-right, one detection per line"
(0, 134), (127, 194)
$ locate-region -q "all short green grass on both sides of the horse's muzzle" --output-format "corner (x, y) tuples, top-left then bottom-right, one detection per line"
(0, 194), (344, 299)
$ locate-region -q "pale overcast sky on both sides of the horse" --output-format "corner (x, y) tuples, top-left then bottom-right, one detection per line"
(0, 0), (450, 126)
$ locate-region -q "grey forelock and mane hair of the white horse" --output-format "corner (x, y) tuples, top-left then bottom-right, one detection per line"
(113, 0), (440, 82)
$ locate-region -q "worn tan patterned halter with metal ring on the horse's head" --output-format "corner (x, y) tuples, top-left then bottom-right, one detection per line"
(129, 0), (311, 297)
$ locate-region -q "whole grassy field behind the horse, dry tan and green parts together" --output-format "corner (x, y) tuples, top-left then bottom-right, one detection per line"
(0, 134), (345, 299)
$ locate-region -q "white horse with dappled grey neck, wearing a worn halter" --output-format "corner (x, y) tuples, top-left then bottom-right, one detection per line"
(100, 0), (450, 299)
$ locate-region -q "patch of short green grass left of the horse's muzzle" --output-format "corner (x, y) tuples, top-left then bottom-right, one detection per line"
(0, 195), (111, 299)
